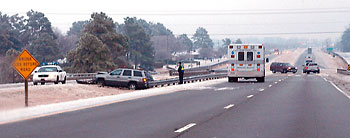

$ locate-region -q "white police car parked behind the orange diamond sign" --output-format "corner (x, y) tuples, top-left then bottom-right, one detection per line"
(33, 65), (67, 85)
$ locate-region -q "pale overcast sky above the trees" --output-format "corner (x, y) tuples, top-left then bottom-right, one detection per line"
(0, 0), (350, 39)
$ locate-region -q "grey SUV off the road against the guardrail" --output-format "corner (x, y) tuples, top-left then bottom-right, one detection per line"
(96, 69), (153, 89)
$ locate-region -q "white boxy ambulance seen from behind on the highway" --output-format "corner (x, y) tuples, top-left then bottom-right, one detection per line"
(228, 44), (269, 82)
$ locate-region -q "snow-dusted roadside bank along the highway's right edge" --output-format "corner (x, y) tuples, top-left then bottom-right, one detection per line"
(314, 49), (350, 94)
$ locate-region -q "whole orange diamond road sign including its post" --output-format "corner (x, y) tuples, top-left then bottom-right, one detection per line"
(12, 49), (39, 107)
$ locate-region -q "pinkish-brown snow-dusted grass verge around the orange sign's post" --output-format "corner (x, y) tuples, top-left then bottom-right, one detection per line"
(0, 84), (131, 111)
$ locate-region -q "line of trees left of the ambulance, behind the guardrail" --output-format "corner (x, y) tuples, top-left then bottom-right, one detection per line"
(0, 10), (239, 83)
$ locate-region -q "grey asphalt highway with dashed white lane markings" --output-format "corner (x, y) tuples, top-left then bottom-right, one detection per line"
(0, 51), (350, 138)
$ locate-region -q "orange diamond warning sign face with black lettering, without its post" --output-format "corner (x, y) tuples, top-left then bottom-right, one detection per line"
(12, 49), (39, 79)
